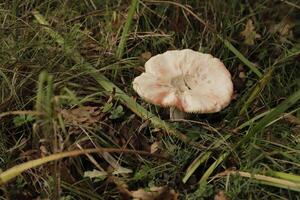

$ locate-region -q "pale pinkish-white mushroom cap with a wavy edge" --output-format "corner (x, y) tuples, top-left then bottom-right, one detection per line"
(133, 49), (233, 113)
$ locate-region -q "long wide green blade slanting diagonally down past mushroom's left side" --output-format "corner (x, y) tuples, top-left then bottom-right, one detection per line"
(33, 12), (203, 148)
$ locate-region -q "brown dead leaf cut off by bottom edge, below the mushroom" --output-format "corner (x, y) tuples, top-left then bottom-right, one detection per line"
(131, 187), (178, 200)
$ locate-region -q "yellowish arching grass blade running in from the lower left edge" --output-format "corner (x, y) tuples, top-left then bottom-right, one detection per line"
(0, 148), (164, 185)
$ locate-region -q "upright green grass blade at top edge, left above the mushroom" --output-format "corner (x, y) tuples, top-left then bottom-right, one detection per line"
(116, 0), (139, 58)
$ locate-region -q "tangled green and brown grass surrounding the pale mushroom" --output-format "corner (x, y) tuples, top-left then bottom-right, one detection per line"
(0, 0), (300, 199)
